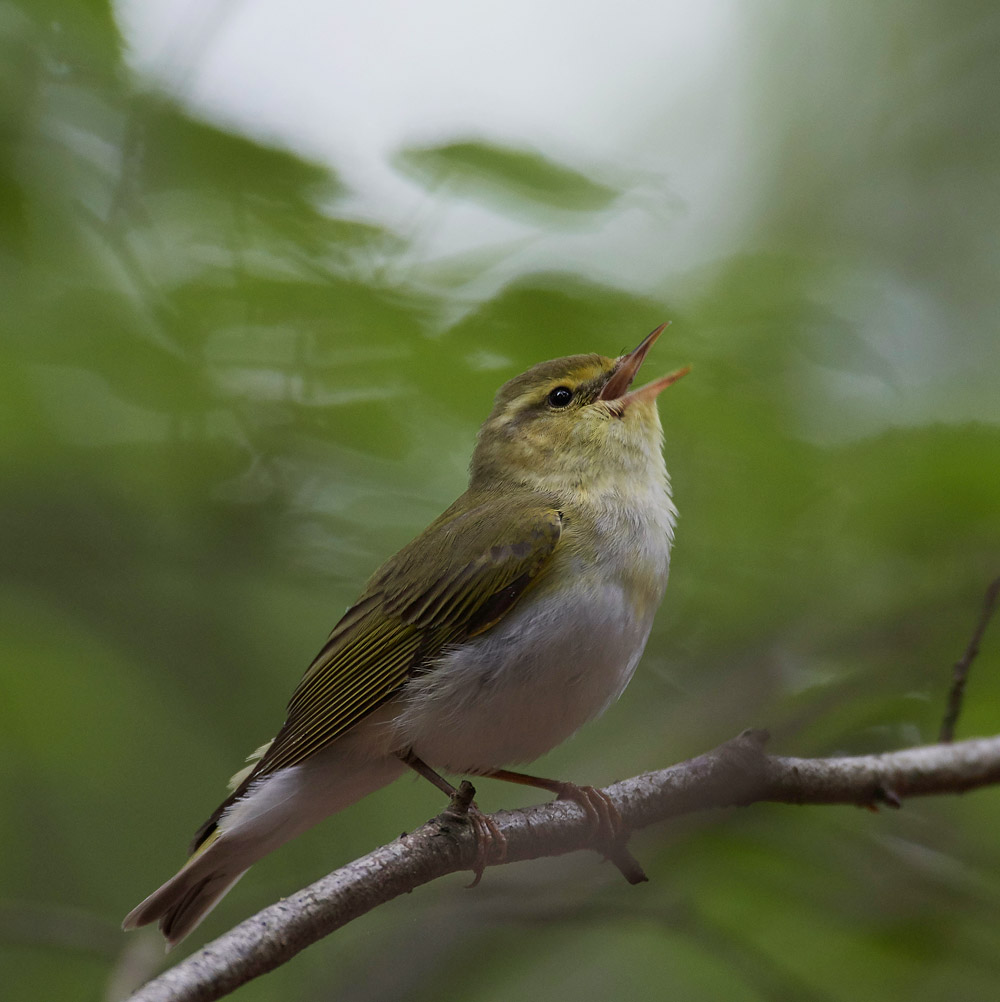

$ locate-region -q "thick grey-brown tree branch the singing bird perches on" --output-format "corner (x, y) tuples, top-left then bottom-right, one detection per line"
(130, 730), (1000, 1002)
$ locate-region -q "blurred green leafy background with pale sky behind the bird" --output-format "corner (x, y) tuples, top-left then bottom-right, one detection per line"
(0, 0), (1000, 1002)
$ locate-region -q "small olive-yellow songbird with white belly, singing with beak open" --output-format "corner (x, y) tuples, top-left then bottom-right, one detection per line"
(124, 324), (687, 947)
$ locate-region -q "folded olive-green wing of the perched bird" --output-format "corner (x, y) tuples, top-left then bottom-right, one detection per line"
(245, 495), (562, 776)
